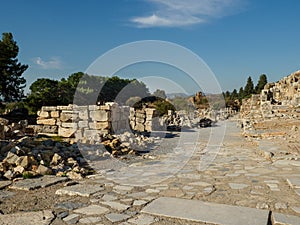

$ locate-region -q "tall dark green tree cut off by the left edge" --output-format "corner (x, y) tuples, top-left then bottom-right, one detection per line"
(0, 33), (28, 102)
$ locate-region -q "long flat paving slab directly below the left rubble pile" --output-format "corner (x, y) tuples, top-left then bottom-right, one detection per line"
(9, 175), (68, 191)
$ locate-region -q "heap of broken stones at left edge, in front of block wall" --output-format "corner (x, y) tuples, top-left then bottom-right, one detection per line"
(0, 137), (91, 180)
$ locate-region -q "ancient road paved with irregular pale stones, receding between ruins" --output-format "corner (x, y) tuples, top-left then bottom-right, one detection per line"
(0, 122), (300, 225)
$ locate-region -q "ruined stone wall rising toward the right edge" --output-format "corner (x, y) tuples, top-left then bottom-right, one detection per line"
(240, 71), (300, 129)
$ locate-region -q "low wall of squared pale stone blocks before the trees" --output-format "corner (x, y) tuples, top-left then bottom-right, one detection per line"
(37, 103), (159, 139)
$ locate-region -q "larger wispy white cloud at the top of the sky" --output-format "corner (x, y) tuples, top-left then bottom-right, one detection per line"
(131, 0), (245, 28)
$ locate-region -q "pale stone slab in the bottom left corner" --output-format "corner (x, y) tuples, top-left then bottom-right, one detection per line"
(0, 210), (54, 225)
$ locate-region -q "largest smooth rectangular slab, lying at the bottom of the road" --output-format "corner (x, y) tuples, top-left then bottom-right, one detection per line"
(142, 197), (269, 225)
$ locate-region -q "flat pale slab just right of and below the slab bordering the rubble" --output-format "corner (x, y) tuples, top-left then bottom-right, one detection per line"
(55, 184), (104, 197)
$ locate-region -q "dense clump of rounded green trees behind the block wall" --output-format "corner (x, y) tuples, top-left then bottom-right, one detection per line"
(26, 72), (149, 113)
